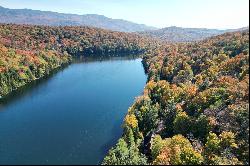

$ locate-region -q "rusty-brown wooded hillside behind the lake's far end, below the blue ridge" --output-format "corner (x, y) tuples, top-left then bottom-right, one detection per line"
(0, 24), (155, 56)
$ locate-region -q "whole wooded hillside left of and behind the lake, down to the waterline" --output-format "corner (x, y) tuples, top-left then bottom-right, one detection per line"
(0, 24), (156, 97)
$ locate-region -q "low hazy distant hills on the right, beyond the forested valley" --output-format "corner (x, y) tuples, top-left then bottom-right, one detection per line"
(139, 26), (249, 42)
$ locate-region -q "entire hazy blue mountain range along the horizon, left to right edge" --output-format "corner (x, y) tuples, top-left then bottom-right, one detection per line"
(0, 6), (249, 42)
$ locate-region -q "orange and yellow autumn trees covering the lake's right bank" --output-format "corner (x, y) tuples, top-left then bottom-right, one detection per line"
(103, 30), (249, 165)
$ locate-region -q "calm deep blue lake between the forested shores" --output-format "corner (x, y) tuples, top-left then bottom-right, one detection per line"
(0, 58), (147, 164)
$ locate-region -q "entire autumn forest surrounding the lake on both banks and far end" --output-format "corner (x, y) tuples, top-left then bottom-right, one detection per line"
(0, 1), (249, 165)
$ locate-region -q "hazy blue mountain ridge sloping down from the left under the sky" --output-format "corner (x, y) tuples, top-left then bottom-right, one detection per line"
(0, 6), (156, 32)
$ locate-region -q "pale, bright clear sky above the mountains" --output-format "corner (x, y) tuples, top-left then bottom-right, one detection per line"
(0, 0), (249, 29)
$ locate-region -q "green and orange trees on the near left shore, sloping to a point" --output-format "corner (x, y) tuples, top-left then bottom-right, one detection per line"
(0, 43), (71, 98)
